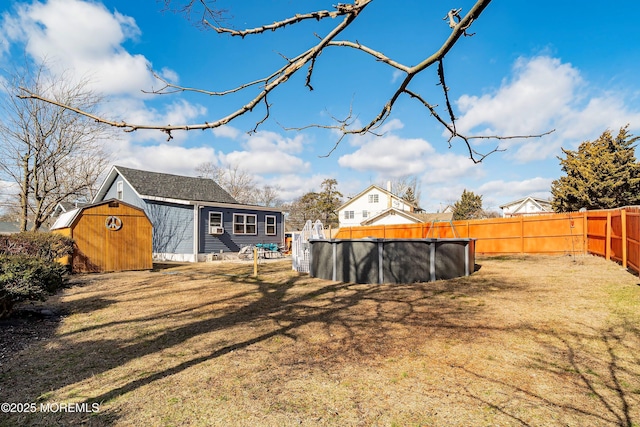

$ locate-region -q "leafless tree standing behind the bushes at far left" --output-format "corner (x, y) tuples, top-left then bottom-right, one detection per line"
(0, 65), (113, 231)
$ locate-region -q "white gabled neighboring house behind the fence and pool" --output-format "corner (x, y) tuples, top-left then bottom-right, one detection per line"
(338, 185), (420, 227)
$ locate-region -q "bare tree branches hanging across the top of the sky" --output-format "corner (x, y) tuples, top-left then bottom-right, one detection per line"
(18, 0), (548, 162)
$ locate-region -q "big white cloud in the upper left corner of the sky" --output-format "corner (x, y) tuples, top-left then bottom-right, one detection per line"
(0, 0), (158, 96)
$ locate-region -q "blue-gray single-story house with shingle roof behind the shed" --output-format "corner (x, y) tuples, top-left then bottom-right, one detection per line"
(93, 166), (284, 262)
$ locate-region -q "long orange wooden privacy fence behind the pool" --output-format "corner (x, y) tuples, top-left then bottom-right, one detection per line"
(335, 206), (640, 271)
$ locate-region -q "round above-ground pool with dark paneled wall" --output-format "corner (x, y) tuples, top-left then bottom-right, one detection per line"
(310, 239), (475, 283)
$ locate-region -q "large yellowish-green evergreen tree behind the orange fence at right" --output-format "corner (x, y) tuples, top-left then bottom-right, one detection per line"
(551, 125), (640, 212)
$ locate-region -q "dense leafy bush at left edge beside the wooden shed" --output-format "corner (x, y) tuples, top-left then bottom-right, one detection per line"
(0, 233), (73, 318)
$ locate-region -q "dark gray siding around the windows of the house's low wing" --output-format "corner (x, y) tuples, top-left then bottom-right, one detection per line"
(198, 206), (284, 254)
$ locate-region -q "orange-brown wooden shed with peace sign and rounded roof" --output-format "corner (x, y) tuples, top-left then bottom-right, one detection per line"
(51, 199), (153, 273)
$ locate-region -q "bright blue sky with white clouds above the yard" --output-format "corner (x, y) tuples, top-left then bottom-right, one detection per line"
(0, 0), (640, 211)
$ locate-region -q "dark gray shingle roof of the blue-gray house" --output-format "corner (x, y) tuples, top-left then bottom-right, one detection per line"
(115, 166), (238, 203)
